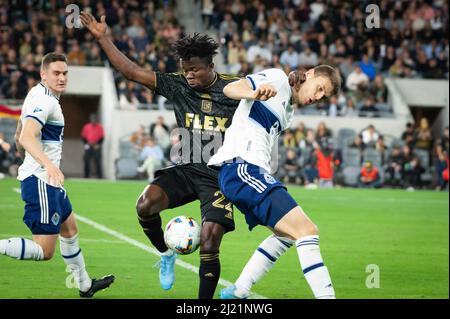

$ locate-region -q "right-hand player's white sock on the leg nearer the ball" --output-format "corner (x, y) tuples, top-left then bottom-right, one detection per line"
(235, 235), (294, 298)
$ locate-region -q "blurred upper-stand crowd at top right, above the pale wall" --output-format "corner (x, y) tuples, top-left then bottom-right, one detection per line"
(209, 0), (449, 116)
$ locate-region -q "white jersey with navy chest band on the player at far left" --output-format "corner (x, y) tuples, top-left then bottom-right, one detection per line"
(17, 83), (64, 183)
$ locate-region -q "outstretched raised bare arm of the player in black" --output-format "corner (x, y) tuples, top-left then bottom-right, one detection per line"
(80, 11), (156, 90)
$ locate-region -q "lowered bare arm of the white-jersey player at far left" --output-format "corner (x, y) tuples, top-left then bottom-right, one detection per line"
(18, 119), (64, 187)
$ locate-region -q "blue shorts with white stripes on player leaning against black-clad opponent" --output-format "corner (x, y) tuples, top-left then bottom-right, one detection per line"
(219, 160), (298, 230)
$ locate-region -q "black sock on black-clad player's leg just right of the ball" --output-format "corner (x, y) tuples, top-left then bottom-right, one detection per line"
(198, 251), (220, 299)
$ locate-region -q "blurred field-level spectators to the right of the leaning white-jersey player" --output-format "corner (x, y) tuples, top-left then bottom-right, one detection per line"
(277, 118), (449, 190)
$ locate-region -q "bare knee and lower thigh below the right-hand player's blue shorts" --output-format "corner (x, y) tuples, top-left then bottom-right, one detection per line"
(274, 206), (318, 240)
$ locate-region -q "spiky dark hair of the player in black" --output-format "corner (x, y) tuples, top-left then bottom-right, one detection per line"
(172, 33), (219, 64)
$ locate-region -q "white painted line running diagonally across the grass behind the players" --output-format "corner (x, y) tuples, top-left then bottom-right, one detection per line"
(13, 188), (267, 299)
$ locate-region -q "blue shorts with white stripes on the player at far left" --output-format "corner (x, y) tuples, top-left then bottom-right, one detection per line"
(20, 175), (72, 235)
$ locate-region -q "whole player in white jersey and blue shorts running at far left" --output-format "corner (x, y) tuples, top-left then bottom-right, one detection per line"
(0, 53), (114, 298)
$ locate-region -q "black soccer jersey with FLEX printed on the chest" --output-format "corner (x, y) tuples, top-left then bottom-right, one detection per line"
(155, 72), (239, 168)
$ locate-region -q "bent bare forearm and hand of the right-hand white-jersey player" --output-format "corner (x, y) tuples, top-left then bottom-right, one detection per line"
(223, 79), (277, 101)
